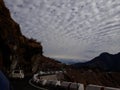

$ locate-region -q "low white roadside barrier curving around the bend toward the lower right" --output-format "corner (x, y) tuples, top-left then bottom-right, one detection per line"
(29, 71), (120, 90)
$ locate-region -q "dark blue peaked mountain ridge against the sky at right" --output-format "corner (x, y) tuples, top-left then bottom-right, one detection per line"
(72, 52), (120, 71)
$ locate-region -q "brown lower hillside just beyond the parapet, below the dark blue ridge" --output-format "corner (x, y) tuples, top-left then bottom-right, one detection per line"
(66, 69), (120, 88)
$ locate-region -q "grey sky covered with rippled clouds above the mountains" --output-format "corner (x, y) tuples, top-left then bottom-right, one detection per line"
(5, 0), (120, 61)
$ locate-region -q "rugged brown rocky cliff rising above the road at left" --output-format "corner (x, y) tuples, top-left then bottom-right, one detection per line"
(0, 0), (63, 72)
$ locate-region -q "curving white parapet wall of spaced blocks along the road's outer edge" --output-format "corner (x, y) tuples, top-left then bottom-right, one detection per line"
(33, 73), (120, 90)
